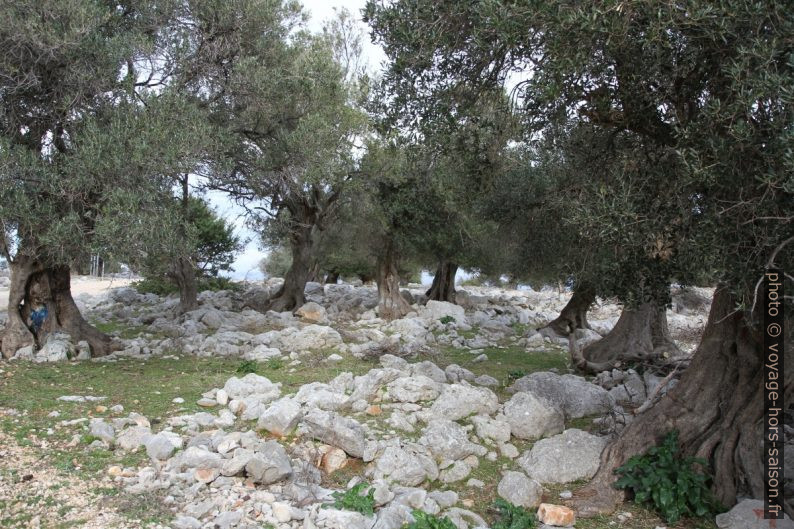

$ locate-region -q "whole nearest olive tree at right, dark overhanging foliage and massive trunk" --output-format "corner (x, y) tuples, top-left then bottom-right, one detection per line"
(367, 0), (794, 514)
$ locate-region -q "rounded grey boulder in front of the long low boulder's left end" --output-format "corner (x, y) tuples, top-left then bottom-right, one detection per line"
(503, 391), (565, 439)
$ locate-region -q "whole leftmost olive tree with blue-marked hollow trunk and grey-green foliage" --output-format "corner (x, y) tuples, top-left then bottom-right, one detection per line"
(0, 0), (210, 357)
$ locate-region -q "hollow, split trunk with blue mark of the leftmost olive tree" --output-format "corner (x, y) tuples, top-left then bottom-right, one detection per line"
(2, 256), (113, 358)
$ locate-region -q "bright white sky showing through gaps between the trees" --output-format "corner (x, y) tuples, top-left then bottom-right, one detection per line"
(207, 0), (386, 281)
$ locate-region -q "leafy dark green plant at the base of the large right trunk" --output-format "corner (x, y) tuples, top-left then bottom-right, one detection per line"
(614, 430), (721, 524)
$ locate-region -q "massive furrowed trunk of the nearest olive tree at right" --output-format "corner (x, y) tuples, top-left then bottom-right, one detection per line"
(573, 288), (794, 516)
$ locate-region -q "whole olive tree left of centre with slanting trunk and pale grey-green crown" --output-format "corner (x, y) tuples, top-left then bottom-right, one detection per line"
(207, 12), (366, 310)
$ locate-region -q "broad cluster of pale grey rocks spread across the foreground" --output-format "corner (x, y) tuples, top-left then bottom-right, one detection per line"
(72, 355), (613, 529)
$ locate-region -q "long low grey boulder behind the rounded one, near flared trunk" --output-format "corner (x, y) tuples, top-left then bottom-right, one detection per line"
(509, 371), (613, 419)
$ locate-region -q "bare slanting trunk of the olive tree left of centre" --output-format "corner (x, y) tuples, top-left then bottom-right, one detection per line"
(266, 224), (315, 312)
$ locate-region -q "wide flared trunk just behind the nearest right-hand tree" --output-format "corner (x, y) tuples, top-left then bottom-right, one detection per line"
(574, 301), (680, 373)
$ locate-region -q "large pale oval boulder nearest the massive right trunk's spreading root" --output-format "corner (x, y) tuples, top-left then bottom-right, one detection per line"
(518, 428), (607, 483)
